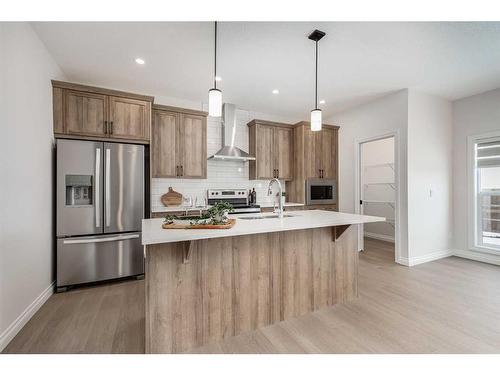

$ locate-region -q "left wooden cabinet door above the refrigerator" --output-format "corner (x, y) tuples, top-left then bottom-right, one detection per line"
(63, 90), (107, 136)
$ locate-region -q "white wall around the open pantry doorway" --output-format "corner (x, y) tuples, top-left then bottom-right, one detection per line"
(325, 90), (408, 259)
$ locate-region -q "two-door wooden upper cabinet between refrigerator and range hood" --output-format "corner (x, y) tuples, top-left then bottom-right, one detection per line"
(151, 105), (207, 178)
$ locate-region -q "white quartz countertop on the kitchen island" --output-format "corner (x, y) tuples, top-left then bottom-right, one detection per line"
(142, 210), (385, 245)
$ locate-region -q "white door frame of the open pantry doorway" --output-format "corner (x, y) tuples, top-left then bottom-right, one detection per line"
(354, 130), (401, 262)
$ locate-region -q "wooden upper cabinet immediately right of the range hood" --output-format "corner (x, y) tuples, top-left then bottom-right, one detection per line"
(248, 120), (293, 180)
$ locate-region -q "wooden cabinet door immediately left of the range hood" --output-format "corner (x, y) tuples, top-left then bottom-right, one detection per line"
(179, 114), (207, 178)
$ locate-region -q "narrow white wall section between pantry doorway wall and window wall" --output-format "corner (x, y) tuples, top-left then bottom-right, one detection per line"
(408, 90), (453, 263)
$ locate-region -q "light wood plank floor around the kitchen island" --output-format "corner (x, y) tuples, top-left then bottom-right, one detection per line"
(4, 239), (500, 353)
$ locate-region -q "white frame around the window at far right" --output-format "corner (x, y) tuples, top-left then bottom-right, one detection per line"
(467, 131), (500, 255)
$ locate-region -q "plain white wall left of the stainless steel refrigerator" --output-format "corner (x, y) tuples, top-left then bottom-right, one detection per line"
(0, 23), (64, 350)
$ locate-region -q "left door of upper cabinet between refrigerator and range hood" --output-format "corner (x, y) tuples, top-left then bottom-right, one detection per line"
(151, 111), (180, 178)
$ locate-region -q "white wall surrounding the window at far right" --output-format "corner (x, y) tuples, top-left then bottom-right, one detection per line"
(453, 89), (500, 264)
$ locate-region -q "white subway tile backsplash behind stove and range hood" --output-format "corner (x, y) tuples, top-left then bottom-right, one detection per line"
(151, 110), (292, 212)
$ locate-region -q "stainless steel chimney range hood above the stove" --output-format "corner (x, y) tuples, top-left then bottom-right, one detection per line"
(209, 103), (255, 161)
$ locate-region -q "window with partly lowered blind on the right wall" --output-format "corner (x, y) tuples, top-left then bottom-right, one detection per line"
(471, 137), (500, 251)
